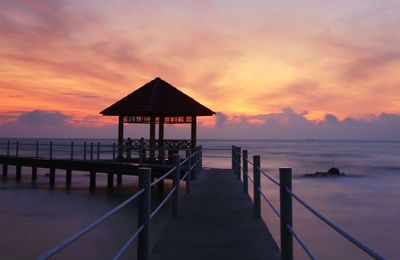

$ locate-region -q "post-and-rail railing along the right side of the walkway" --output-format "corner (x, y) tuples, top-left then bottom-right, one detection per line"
(232, 146), (385, 260)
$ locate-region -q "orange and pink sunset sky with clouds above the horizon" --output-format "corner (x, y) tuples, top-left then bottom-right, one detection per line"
(0, 0), (400, 139)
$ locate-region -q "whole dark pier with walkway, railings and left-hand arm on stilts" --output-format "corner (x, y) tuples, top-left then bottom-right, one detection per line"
(0, 142), (385, 260)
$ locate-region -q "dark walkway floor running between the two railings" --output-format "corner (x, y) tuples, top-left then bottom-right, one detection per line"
(151, 169), (280, 260)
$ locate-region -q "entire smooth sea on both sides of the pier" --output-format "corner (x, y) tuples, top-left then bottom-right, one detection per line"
(0, 139), (400, 259)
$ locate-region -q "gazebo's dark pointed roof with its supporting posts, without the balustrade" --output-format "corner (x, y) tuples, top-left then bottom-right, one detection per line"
(100, 77), (215, 159)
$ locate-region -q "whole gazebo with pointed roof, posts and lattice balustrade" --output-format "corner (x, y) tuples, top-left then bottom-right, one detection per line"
(100, 77), (215, 163)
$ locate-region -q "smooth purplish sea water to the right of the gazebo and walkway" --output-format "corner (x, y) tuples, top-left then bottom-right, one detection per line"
(203, 140), (400, 259)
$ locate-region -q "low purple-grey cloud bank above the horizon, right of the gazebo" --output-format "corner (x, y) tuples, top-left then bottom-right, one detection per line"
(201, 108), (400, 140)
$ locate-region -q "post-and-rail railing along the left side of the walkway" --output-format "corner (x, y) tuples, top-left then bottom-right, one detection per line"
(37, 147), (202, 260)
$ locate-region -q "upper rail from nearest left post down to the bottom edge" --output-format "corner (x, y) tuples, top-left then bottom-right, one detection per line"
(37, 189), (144, 260)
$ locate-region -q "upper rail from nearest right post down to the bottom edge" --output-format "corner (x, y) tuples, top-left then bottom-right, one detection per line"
(286, 188), (385, 259)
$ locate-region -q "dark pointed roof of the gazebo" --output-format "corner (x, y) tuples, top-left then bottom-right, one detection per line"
(100, 77), (215, 116)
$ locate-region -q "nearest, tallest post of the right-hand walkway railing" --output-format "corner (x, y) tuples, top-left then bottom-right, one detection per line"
(279, 168), (293, 260)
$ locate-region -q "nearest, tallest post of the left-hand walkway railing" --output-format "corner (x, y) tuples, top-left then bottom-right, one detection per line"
(138, 168), (151, 260)
